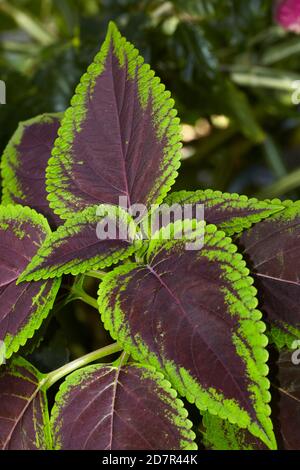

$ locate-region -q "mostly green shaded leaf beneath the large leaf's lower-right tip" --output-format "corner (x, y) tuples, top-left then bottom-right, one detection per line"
(202, 413), (268, 450)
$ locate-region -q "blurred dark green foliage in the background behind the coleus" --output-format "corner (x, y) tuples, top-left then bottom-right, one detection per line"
(0, 0), (300, 368)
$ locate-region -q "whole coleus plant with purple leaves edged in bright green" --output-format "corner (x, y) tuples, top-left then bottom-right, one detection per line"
(0, 23), (300, 450)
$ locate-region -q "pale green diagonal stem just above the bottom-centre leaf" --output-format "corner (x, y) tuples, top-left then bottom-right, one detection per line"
(44, 343), (123, 389)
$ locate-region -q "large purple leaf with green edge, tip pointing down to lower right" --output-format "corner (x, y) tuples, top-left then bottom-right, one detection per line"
(98, 221), (276, 448)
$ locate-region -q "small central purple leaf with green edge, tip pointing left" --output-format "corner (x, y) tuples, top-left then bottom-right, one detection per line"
(18, 204), (140, 282)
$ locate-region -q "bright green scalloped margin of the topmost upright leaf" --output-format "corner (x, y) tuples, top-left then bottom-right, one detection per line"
(46, 21), (182, 219)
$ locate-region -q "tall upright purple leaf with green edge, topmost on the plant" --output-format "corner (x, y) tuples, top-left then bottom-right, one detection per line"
(47, 23), (181, 219)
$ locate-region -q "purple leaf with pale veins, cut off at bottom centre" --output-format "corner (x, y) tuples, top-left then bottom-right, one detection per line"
(51, 364), (197, 450)
